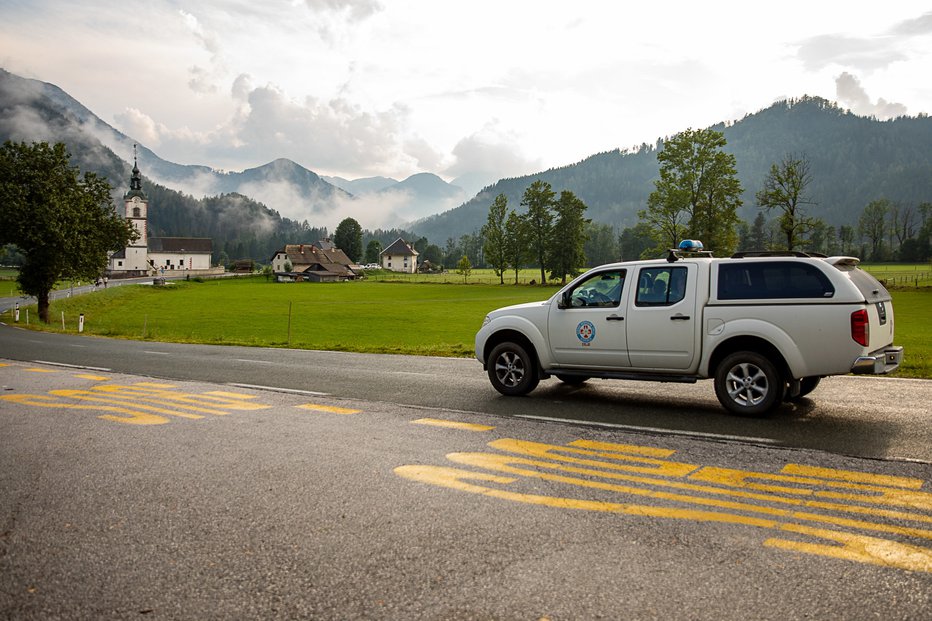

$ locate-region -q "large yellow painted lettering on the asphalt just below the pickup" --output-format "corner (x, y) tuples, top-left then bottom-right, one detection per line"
(395, 438), (932, 573)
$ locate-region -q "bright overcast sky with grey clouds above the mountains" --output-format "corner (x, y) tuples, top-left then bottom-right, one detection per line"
(0, 0), (932, 180)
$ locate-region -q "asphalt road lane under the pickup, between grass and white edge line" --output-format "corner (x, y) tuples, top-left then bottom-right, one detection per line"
(0, 325), (932, 463)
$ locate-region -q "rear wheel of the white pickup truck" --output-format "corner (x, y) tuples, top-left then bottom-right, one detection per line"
(715, 351), (786, 416)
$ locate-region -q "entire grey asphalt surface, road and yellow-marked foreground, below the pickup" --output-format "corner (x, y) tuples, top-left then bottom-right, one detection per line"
(0, 326), (932, 620)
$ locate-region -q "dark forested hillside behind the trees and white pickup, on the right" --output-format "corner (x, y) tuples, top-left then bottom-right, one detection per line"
(409, 97), (932, 241)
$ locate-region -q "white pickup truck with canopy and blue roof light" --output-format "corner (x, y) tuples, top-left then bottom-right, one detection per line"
(476, 242), (903, 416)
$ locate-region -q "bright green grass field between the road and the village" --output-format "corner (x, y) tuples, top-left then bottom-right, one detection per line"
(4, 277), (932, 378)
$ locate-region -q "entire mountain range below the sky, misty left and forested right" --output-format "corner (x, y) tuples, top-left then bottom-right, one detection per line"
(0, 70), (932, 260)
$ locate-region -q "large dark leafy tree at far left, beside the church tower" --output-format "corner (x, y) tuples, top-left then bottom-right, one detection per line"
(0, 142), (136, 323)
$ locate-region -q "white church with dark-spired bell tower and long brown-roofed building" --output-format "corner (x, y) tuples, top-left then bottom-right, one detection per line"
(109, 146), (213, 278)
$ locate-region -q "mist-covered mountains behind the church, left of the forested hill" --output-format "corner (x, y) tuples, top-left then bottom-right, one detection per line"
(0, 69), (468, 230)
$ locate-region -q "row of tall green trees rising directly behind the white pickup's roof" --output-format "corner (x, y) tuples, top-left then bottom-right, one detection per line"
(620, 130), (932, 261)
